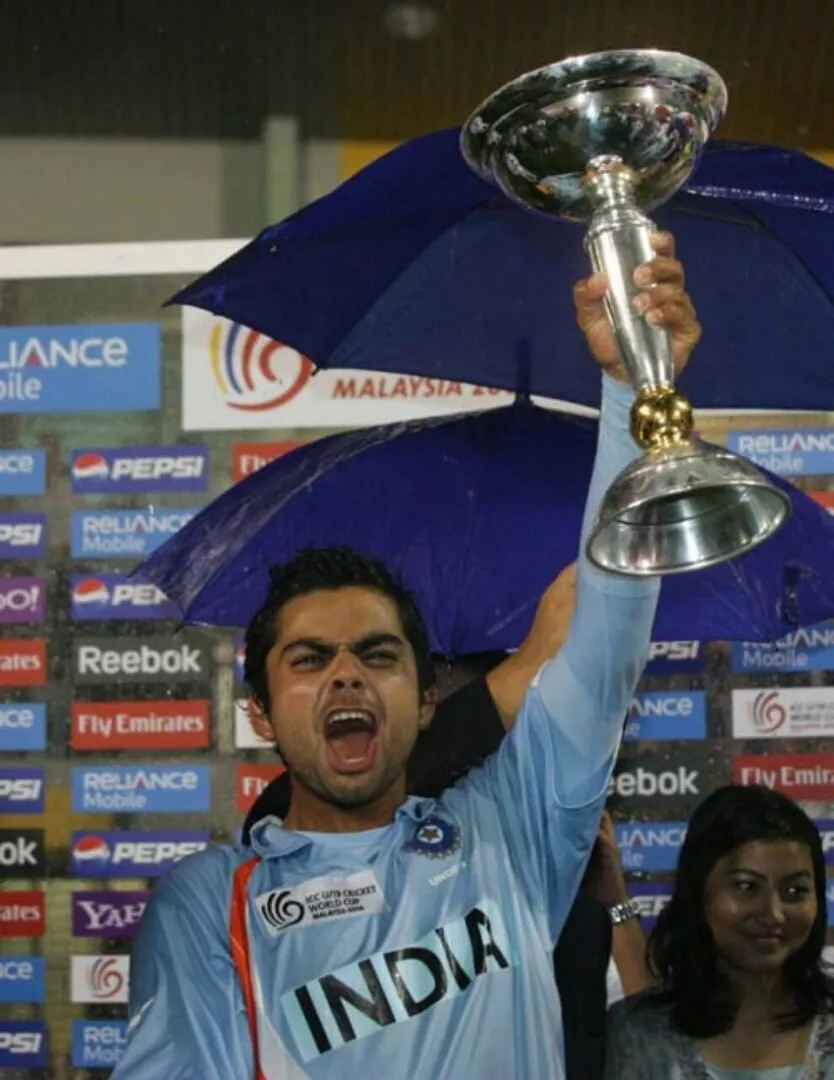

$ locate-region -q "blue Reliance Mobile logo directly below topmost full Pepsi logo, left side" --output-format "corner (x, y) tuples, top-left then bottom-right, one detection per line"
(72, 507), (199, 558)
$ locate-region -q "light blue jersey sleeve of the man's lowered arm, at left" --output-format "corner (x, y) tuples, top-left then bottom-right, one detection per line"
(112, 850), (254, 1080)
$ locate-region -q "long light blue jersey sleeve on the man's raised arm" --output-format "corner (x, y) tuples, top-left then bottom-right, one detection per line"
(456, 377), (659, 941)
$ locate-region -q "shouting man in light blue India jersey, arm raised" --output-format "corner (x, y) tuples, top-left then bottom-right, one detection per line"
(113, 238), (699, 1080)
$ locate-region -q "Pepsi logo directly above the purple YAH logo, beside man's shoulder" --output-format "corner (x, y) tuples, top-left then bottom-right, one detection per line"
(72, 829), (210, 878)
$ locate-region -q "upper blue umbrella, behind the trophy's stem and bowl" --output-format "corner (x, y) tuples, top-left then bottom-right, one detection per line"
(174, 131), (834, 409)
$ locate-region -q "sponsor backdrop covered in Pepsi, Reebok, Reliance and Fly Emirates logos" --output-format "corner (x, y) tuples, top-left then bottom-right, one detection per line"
(0, 148), (834, 1080)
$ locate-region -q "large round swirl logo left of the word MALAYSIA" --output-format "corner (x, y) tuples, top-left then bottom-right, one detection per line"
(209, 319), (313, 413)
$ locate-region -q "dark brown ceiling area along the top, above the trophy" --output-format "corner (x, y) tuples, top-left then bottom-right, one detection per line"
(0, 0), (834, 149)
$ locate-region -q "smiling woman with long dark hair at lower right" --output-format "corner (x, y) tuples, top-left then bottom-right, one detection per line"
(605, 786), (834, 1080)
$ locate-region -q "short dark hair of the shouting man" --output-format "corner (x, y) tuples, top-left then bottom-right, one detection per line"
(244, 548), (434, 710)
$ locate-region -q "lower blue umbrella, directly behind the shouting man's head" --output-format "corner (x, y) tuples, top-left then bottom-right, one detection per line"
(139, 404), (834, 656)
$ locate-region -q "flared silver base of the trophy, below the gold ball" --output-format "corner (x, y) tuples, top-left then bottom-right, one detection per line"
(586, 443), (791, 577)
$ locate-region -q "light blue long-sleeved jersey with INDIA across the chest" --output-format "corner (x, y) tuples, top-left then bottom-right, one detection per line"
(113, 379), (658, 1080)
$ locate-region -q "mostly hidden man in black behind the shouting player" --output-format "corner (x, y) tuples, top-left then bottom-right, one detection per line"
(243, 564), (648, 1080)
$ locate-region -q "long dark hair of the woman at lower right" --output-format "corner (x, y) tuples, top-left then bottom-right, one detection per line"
(646, 785), (834, 1039)
